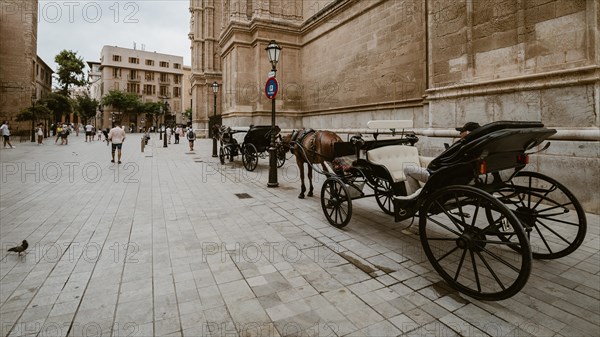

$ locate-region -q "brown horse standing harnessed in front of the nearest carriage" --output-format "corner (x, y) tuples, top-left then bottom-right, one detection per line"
(282, 129), (342, 199)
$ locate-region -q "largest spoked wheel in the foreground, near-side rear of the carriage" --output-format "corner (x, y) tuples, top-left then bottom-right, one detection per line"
(419, 186), (532, 300)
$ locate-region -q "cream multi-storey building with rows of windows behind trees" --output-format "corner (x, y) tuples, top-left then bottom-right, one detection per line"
(98, 46), (184, 130)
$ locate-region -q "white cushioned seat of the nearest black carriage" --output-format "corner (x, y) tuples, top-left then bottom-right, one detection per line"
(367, 145), (421, 183)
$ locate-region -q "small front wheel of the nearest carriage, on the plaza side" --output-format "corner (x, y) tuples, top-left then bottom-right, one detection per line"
(321, 177), (352, 228)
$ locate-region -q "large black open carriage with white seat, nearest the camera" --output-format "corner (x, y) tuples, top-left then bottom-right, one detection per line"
(321, 122), (587, 300)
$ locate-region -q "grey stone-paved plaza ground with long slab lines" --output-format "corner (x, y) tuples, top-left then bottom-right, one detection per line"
(0, 134), (600, 336)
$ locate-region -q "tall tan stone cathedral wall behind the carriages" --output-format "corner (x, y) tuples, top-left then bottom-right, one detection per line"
(197, 0), (600, 213)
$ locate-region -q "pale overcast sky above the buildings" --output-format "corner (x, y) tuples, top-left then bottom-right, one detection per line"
(37, 0), (191, 72)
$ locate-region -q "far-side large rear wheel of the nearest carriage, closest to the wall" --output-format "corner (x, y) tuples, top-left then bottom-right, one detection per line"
(488, 171), (587, 259)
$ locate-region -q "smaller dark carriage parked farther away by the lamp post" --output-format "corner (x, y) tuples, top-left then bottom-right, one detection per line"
(219, 125), (286, 171)
